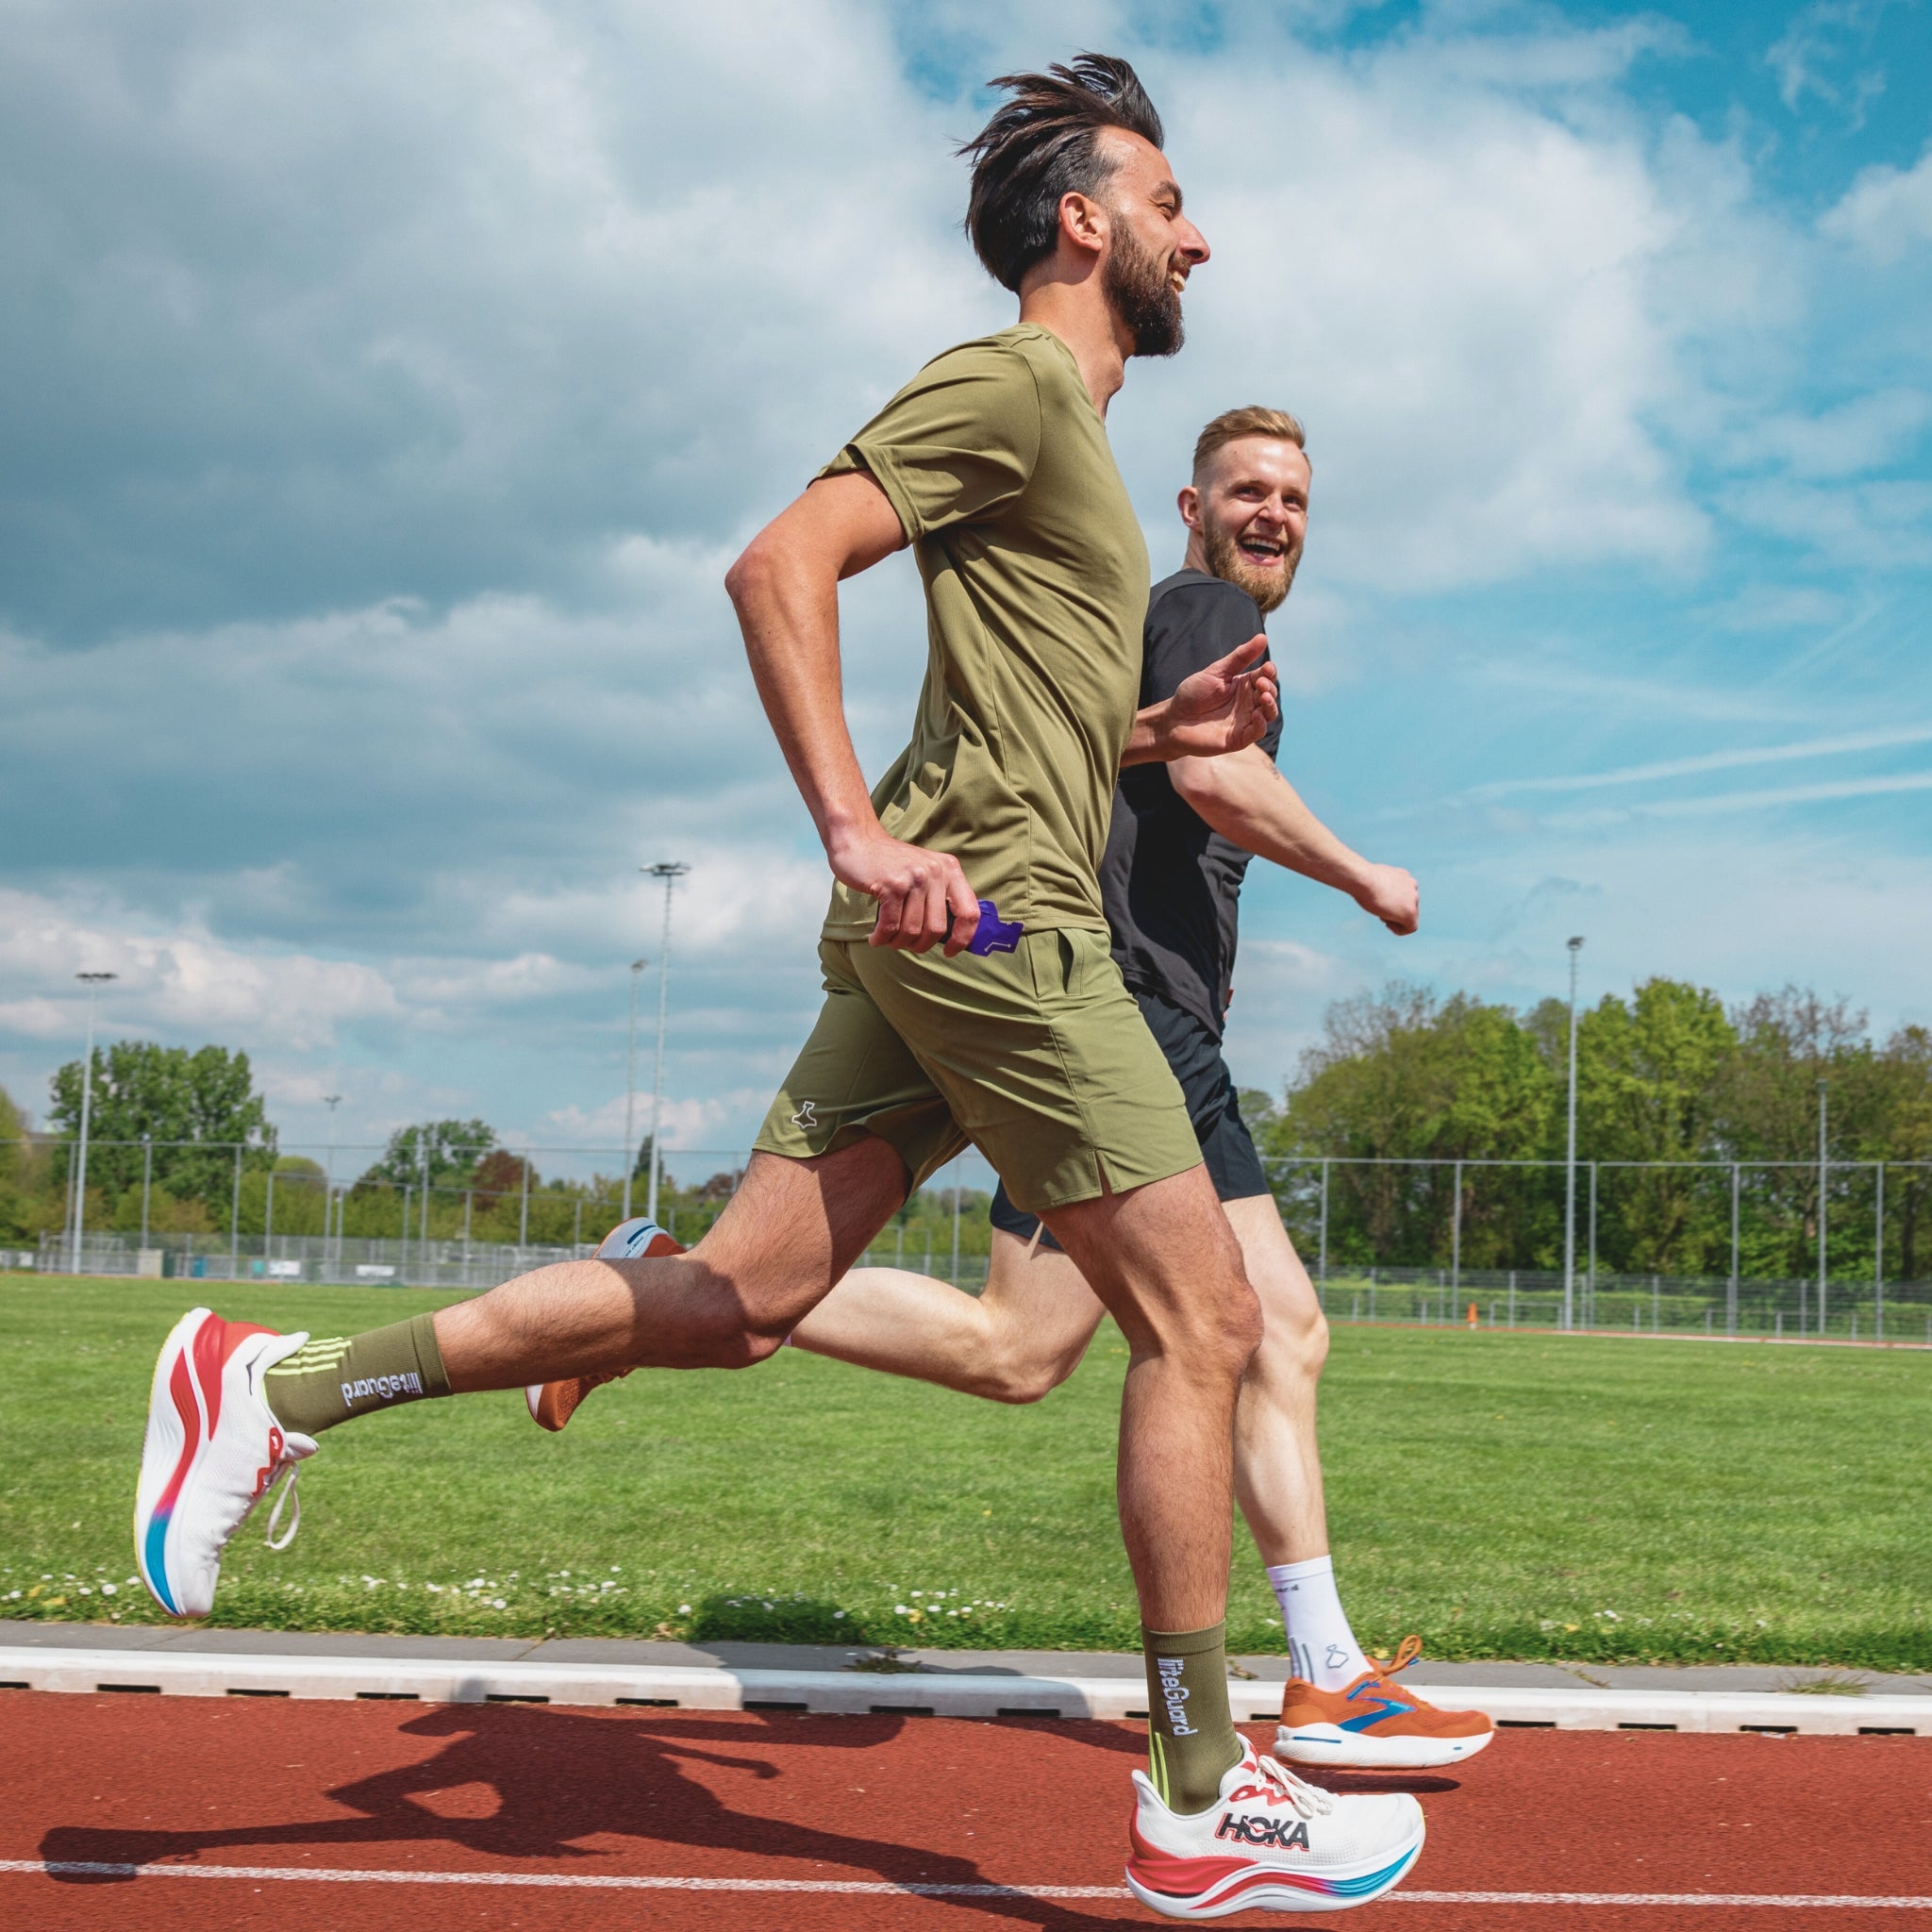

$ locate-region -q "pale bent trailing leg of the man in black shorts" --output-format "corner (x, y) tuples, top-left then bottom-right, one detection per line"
(792, 1229), (1108, 1403)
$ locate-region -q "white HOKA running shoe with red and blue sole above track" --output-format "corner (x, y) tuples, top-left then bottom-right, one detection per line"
(1126, 1739), (1424, 1919)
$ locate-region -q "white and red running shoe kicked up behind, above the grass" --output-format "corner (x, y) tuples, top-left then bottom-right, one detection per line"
(133, 1307), (315, 1617)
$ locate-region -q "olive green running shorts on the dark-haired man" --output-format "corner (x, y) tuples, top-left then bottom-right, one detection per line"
(758, 927), (1202, 1213)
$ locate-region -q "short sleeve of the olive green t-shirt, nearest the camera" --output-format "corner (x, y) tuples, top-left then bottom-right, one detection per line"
(819, 341), (1040, 542)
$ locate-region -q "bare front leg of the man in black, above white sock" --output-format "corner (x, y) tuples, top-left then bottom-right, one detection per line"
(1223, 1194), (1327, 1563)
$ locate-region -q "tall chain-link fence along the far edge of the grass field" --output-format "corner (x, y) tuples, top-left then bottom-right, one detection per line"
(15, 1141), (1932, 1342)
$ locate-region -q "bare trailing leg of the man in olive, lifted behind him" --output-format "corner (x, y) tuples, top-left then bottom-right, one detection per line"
(437, 1134), (907, 1393)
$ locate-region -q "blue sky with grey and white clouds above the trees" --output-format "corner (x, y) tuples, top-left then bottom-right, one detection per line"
(0, 0), (1932, 1165)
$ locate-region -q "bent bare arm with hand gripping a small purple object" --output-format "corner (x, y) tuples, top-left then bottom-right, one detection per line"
(724, 475), (979, 955)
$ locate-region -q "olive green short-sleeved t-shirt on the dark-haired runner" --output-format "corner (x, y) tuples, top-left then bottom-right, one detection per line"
(819, 323), (1148, 939)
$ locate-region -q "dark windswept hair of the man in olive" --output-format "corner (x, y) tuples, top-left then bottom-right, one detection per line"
(960, 54), (1161, 293)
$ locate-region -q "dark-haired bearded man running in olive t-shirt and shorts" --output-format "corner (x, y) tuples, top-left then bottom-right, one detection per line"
(135, 56), (1422, 1917)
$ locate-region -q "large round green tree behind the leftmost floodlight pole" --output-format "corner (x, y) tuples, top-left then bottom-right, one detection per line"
(48, 1040), (276, 1209)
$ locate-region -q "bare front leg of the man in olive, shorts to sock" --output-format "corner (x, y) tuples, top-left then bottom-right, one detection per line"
(1045, 1167), (1261, 1631)
